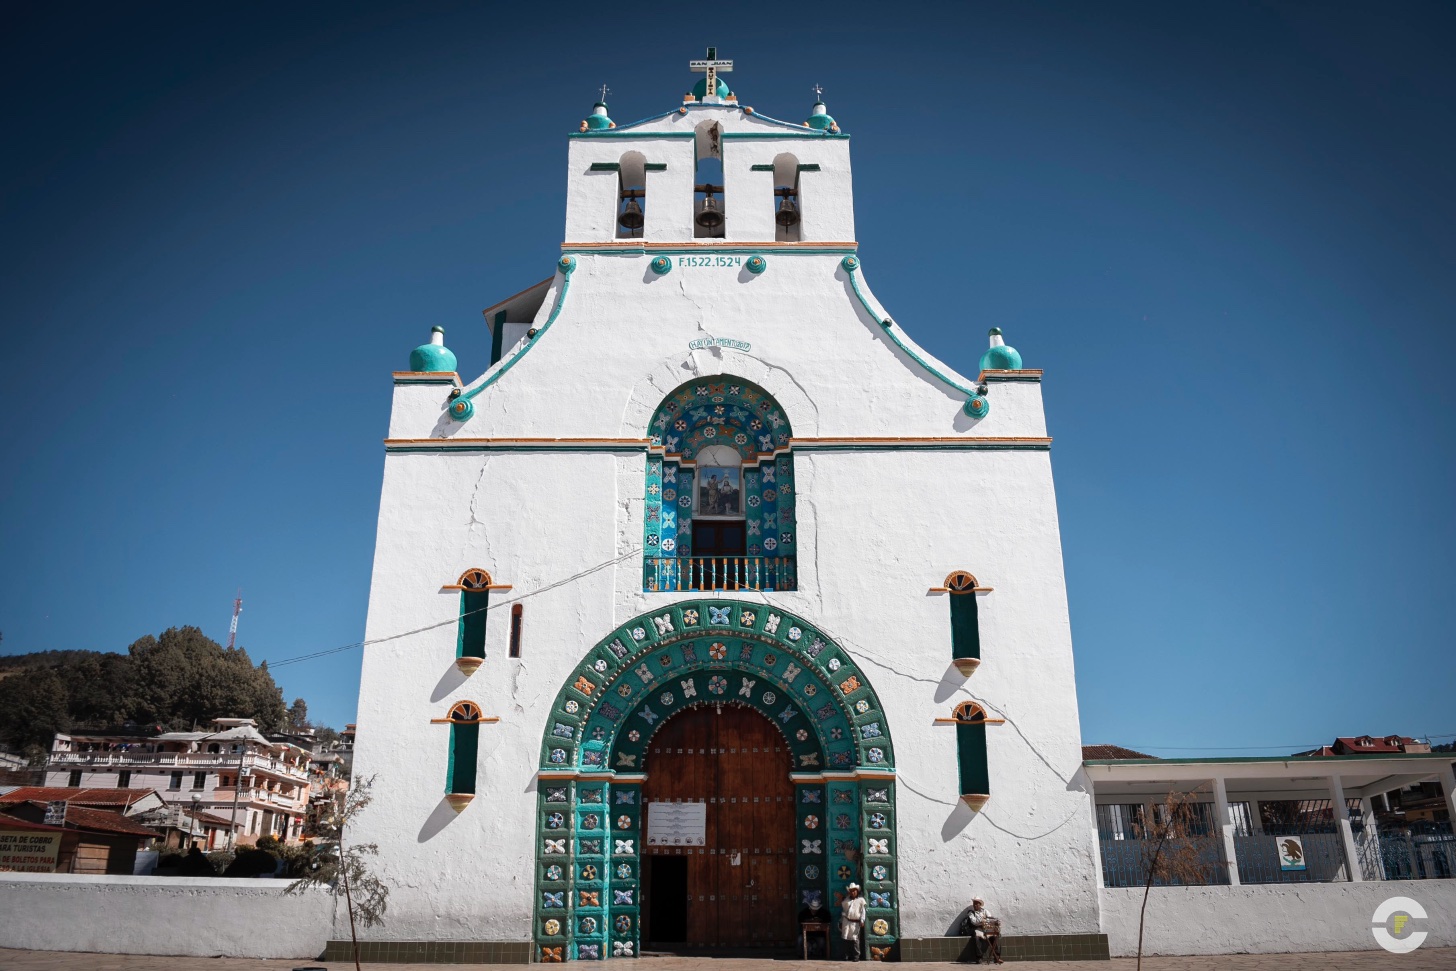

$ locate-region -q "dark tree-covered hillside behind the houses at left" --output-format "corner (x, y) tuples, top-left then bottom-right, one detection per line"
(0, 627), (292, 756)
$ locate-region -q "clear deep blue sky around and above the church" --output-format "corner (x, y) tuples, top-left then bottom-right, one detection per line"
(0, 3), (1456, 754)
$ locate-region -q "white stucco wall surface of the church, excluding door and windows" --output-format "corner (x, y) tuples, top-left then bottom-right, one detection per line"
(346, 85), (1098, 940)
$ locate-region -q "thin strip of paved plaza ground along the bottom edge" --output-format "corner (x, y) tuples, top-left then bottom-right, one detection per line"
(0, 948), (1456, 971)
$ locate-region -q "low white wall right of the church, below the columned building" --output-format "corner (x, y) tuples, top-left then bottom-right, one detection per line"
(1102, 879), (1456, 958)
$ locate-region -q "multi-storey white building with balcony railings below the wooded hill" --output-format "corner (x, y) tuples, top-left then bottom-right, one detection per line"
(45, 718), (313, 849)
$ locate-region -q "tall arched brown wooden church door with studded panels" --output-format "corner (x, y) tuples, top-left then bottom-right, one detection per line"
(642, 705), (798, 949)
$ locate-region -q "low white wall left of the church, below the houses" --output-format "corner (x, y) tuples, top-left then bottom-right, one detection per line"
(0, 873), (335, 958)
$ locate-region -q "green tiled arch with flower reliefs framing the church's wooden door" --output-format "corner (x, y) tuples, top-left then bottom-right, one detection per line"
(533, 600), (900, 961)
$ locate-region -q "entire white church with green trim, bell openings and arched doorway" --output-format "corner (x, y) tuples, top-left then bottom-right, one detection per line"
(355, 57), (1105, 961)
